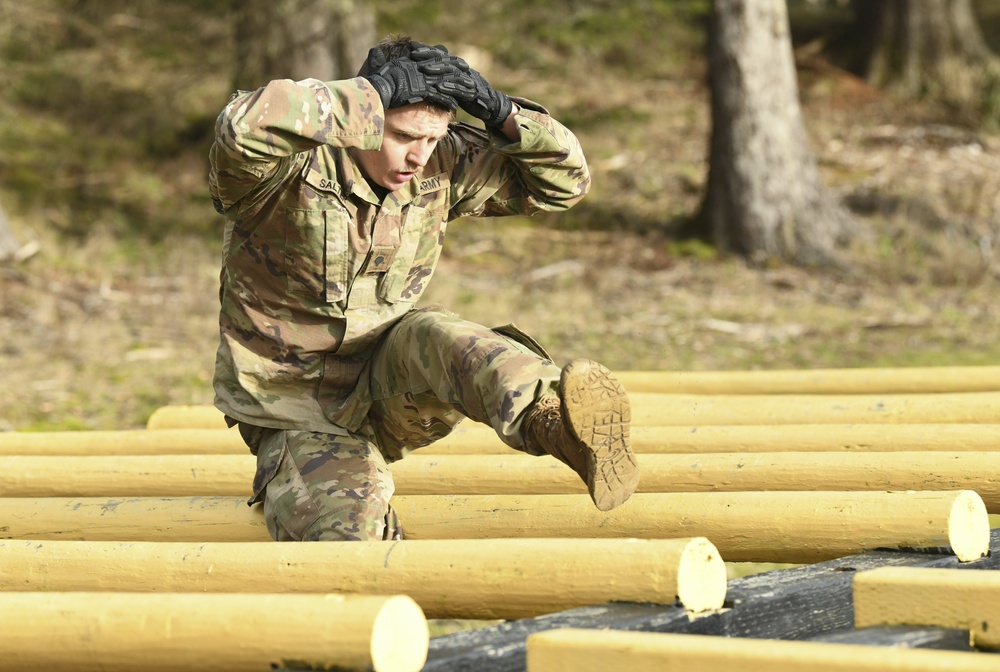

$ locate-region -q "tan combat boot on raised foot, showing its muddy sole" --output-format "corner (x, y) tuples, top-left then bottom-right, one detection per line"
(524, 359), (639, 511)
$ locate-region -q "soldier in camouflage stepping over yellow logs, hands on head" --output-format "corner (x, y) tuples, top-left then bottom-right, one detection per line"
(209, 38), (639, 541)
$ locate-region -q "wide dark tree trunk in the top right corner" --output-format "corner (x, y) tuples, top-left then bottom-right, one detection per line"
(854, 0), (1000, 125)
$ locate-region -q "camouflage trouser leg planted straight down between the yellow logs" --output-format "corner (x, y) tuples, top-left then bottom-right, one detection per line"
(240, 425), (402, 541)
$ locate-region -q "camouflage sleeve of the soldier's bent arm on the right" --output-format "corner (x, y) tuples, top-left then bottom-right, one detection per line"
(450, 99), (590, 218)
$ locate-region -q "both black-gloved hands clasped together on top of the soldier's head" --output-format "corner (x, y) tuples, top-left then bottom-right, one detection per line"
(365, 41), (512, 128)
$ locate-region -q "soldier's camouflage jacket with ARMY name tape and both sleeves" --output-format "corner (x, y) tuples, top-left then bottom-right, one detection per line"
(209, 78), (590, 433)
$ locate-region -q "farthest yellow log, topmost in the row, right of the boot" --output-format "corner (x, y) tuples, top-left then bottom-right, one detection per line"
(615, 366), (1000, 394)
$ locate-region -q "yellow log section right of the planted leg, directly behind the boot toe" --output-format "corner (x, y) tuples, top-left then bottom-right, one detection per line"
(392, 451), (1000, 513)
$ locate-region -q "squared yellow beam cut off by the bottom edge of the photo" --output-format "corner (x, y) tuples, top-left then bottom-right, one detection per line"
(527, 629), (997, 672)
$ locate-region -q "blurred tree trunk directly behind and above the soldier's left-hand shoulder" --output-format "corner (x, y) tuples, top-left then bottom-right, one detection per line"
(235, 0), (376, 90)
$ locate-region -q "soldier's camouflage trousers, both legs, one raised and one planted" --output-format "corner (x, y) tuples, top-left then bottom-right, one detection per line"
(240, 310), (560, 541)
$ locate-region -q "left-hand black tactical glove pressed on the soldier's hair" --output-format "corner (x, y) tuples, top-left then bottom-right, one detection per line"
(362, 42), (462, 110)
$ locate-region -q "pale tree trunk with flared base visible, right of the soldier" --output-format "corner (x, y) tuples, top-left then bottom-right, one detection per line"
(701, 0), (850, 266)
